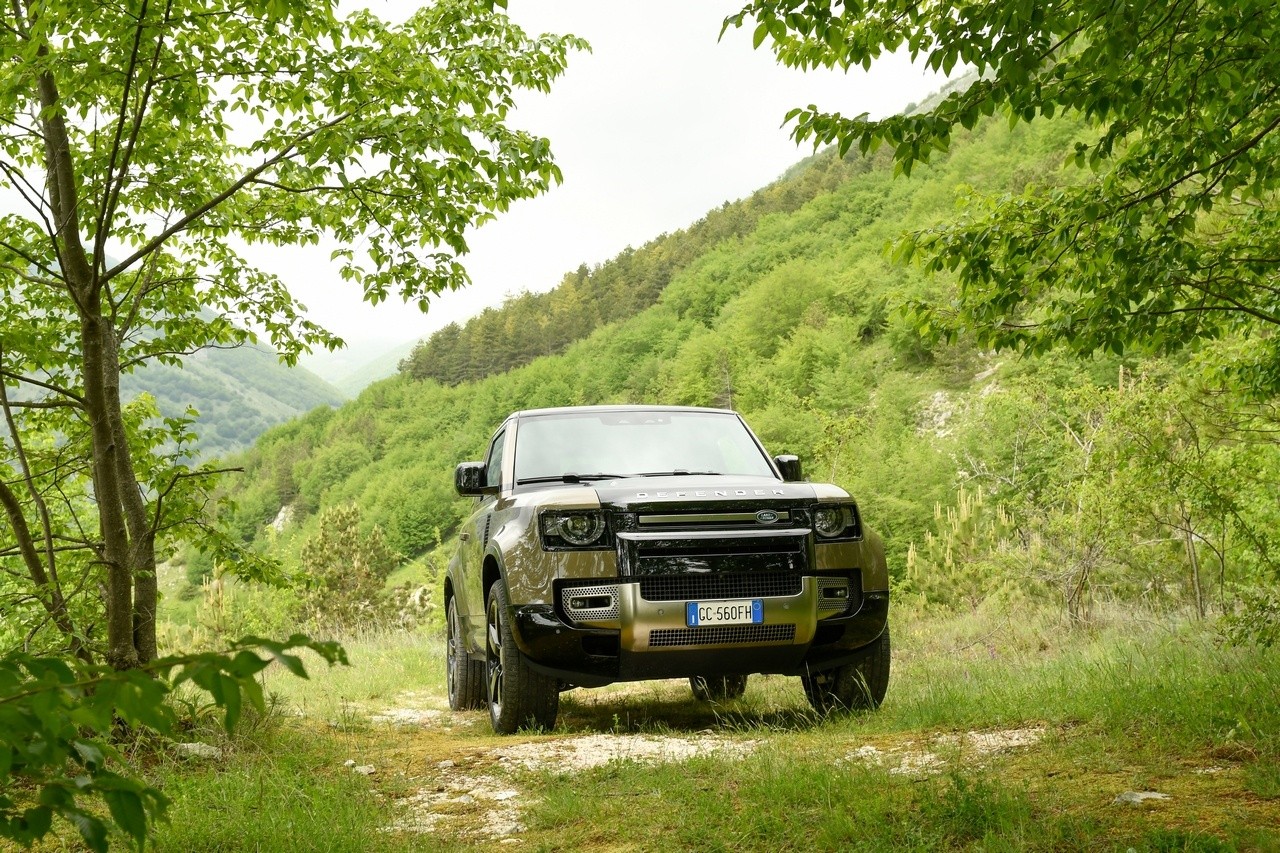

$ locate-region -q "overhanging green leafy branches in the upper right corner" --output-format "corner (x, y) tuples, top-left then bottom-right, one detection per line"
(724, 0), (1280, 391)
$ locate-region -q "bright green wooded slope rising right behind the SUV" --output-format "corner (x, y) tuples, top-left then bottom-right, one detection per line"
(204, 106), (1280, 635)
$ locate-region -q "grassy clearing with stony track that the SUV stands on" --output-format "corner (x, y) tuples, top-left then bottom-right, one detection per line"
(135, 604), (1280, 852)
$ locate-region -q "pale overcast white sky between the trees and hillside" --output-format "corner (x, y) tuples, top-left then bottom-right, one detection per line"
(270, 0), (942, 355)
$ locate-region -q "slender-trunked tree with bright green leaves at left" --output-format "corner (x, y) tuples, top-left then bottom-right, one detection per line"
(0, 0), (585, 667)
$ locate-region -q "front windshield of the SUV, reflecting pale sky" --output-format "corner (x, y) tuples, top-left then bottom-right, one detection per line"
(515, 411), (777, 483)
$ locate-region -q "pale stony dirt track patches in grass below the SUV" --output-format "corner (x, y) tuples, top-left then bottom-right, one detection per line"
(337, 684), (1044, 844)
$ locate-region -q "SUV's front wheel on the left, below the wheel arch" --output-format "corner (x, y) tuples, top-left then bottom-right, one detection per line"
(485, 578), (559, 734)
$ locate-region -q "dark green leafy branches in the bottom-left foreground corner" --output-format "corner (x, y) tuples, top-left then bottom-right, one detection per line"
(0, 635), (346, 852)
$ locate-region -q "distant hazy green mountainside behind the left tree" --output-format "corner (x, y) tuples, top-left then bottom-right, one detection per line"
(120, 346), (343, 459)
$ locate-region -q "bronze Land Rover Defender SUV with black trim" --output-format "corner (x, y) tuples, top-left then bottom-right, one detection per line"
(444, 406), (890, 733)
